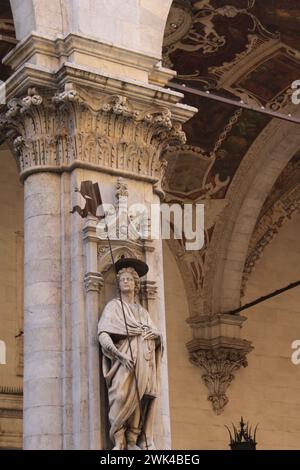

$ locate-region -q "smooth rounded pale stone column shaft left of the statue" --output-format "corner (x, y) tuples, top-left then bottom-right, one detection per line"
(24, 173), (62, 449)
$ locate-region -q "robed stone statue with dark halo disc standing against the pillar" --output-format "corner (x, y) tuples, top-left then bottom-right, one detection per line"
(98, 258), (162, 450)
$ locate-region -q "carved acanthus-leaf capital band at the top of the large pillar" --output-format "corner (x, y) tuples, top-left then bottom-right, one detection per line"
(0, 85), (186, 182)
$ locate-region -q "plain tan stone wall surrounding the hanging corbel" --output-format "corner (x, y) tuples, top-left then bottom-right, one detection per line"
(164, 215), (300, 449)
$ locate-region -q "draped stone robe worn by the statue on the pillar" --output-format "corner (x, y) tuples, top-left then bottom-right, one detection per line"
(98, 299), (162, 440)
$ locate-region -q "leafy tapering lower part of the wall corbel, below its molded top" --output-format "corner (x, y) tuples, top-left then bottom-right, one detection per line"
(190, 347), (249, 415)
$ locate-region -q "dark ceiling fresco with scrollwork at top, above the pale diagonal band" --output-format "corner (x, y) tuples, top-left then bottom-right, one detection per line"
(163, 0), (300, 91)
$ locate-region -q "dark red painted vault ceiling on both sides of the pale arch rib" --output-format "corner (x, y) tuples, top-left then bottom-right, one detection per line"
(163, 0), (300, 308)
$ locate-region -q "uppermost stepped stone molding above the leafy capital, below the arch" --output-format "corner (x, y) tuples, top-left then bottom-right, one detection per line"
(3, 32), (176, 86)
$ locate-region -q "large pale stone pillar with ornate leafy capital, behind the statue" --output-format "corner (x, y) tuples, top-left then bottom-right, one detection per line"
(0, 38), (196, 449)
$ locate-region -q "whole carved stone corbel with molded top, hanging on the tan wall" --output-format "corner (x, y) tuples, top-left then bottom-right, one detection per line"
(187, 315), (253, 415)
